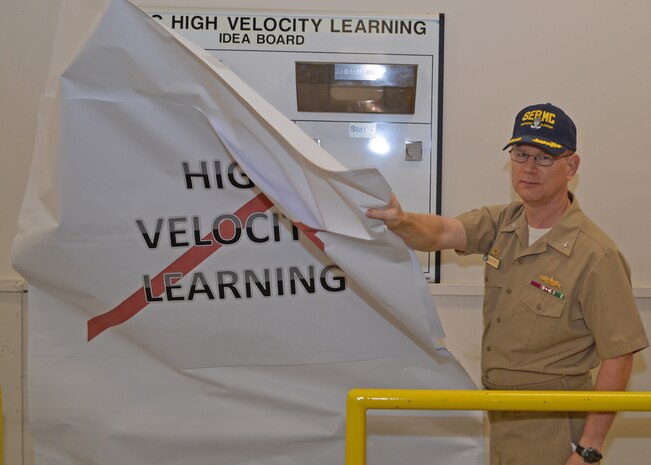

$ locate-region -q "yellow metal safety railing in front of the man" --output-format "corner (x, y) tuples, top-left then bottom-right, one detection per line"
(346, 389), (651, 465)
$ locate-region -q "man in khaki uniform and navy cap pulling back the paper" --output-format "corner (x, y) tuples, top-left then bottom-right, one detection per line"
(367, 104), (648, 465)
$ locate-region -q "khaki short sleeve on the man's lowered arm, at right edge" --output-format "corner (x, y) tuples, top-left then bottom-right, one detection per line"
(580, 246), (649, 360)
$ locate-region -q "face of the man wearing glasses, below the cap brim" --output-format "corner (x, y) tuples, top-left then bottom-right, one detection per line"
(511, 145), (579, 205)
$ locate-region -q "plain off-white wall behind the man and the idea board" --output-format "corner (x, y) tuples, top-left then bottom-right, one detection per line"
(0, 0), (651, 463)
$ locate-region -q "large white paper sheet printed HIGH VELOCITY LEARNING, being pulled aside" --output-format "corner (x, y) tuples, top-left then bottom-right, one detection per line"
(14, 0), (482, 465)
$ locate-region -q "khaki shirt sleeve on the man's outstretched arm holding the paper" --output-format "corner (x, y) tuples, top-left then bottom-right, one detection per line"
(457, 205), (506, 255)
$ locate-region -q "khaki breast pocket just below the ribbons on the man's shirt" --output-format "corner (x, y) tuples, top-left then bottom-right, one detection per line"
(520, 286), (565, 349)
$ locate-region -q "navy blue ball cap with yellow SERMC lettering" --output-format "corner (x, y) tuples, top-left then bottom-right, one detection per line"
(503, 103), (576, 156)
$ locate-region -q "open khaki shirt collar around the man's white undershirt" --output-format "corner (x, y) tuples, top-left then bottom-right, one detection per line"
(500, 192), (583, 256)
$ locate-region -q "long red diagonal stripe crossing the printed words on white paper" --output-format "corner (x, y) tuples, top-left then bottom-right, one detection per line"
(87, 194), (274, 342)
